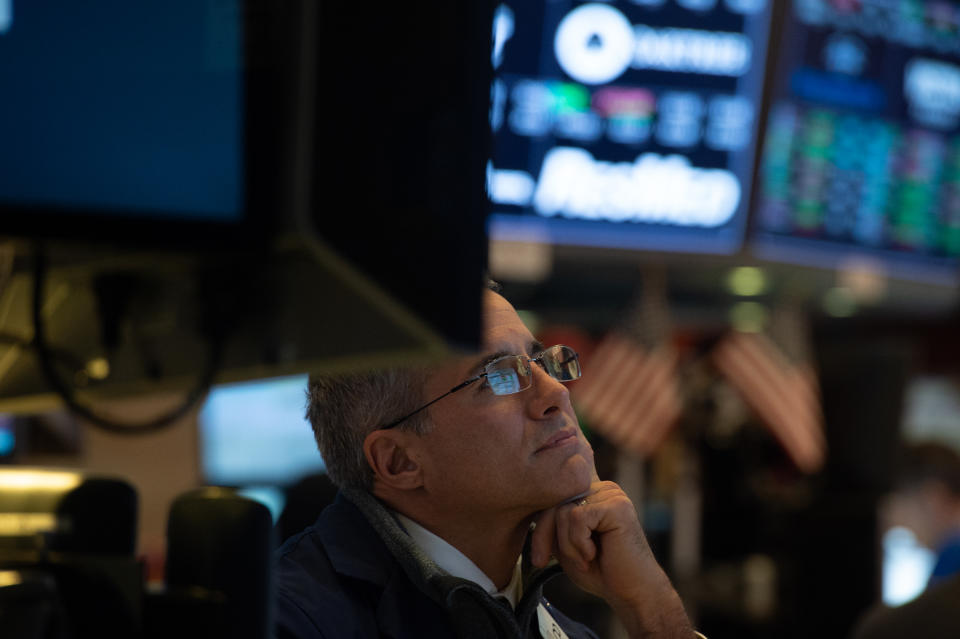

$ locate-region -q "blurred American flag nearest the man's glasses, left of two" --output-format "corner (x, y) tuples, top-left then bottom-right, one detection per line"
(571, 271), (683, 456)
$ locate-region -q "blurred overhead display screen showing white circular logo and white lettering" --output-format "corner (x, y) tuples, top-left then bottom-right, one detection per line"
(488, 0), (771, 253)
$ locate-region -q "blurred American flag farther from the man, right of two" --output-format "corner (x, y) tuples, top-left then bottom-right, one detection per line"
(712, 309), (826, 473)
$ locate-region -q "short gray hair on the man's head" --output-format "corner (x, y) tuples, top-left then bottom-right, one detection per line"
(307, 368), (429, 490)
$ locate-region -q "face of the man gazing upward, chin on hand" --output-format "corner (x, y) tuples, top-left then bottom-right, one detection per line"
(410, 292), (593, 516)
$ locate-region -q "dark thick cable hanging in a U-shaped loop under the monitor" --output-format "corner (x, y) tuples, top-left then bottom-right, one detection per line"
(33, 241), (223, 435)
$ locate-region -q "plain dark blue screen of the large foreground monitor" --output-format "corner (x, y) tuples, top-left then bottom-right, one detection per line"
(0, 0), (244, 221)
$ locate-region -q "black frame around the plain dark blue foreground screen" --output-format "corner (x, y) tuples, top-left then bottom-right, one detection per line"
(0, 0), (309, 250)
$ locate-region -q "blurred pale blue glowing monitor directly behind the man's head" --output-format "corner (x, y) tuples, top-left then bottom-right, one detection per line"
(199, 375), (325, 487)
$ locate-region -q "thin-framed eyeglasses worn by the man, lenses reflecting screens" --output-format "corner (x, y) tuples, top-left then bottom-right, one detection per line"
(381, 344), (581, 430)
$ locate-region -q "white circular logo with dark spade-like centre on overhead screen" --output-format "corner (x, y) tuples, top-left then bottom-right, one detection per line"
(553, 3), (634, 84)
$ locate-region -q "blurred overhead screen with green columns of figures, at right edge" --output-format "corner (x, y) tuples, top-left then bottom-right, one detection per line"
(753, 0), (960, 284)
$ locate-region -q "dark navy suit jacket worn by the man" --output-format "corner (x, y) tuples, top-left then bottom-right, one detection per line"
(276, 494), (596, 639)
